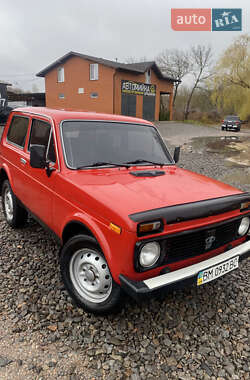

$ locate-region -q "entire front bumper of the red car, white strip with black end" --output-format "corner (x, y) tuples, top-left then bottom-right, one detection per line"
(119, 240), (250, 301)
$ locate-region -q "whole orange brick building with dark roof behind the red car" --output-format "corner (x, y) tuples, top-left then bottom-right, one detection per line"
(37, 52), (178, 120)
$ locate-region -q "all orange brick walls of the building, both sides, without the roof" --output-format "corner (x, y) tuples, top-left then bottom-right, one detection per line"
(45, 57), (173, 120)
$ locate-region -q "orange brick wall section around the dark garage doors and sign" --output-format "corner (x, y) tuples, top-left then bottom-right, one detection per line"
(114, 70), (173, 120)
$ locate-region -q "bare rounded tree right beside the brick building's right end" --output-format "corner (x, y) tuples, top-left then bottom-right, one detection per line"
(156, 49), (191, 105)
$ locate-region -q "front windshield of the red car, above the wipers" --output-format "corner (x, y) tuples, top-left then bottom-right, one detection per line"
(61, 120), (173, 169)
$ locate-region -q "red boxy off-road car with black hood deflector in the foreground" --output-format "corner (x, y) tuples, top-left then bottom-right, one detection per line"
(0, 107), (250, 314)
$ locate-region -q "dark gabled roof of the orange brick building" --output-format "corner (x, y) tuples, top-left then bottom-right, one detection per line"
(36, 51), (178, 82)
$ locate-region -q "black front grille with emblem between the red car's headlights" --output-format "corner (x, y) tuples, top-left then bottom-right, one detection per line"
(162, 220), (240, 264)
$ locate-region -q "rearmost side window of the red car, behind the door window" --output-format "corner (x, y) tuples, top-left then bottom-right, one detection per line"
(7, 116), (29, 148)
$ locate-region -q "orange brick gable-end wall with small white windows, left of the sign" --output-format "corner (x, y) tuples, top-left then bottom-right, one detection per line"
(45, 57), (114, 113)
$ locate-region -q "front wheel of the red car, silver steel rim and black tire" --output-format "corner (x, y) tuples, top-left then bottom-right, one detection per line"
(60, 235), (122, 315)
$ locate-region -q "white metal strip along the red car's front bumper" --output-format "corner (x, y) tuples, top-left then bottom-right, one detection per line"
(143, 241), (250, 289)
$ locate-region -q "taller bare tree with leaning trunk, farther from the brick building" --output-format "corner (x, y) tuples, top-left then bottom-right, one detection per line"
(184, 45), (212, 120)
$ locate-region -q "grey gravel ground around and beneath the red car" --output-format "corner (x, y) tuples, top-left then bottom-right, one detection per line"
(0, 123), (250, 380)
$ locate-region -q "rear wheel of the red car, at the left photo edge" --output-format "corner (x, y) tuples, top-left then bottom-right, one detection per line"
(2, 180), (28, 228)
